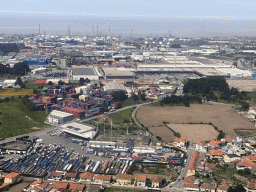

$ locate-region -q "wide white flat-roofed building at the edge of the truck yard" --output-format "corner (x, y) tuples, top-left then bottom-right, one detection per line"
(60, 122), (98, 140)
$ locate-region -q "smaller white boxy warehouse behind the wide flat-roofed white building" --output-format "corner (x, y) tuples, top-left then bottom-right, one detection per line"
(46, 110), (74, 124)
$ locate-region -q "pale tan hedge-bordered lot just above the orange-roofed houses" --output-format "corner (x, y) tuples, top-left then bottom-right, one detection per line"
(168, 124), (219, 142)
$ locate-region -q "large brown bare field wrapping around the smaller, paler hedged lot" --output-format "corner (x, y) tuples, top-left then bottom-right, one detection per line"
(137, 104), (255, 139)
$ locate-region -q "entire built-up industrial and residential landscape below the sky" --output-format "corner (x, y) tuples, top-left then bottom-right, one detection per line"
(0, 21), (256, 192)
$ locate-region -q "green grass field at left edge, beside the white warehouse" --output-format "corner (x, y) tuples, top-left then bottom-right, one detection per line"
(0, 99), (47, 138)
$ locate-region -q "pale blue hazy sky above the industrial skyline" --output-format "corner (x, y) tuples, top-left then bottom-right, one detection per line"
(0, 0), (256, 36)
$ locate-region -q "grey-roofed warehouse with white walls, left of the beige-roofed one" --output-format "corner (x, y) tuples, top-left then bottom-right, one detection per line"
(71, 67), (101, 81)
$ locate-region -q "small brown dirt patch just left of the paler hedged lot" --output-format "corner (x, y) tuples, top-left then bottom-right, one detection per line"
(149, 125), (174, 142)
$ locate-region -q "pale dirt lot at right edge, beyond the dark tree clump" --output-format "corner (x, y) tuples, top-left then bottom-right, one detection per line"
(227, 79), (256, 92)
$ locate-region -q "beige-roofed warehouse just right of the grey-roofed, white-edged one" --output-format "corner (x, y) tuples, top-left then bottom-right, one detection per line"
(103, 67), (135, 79)
